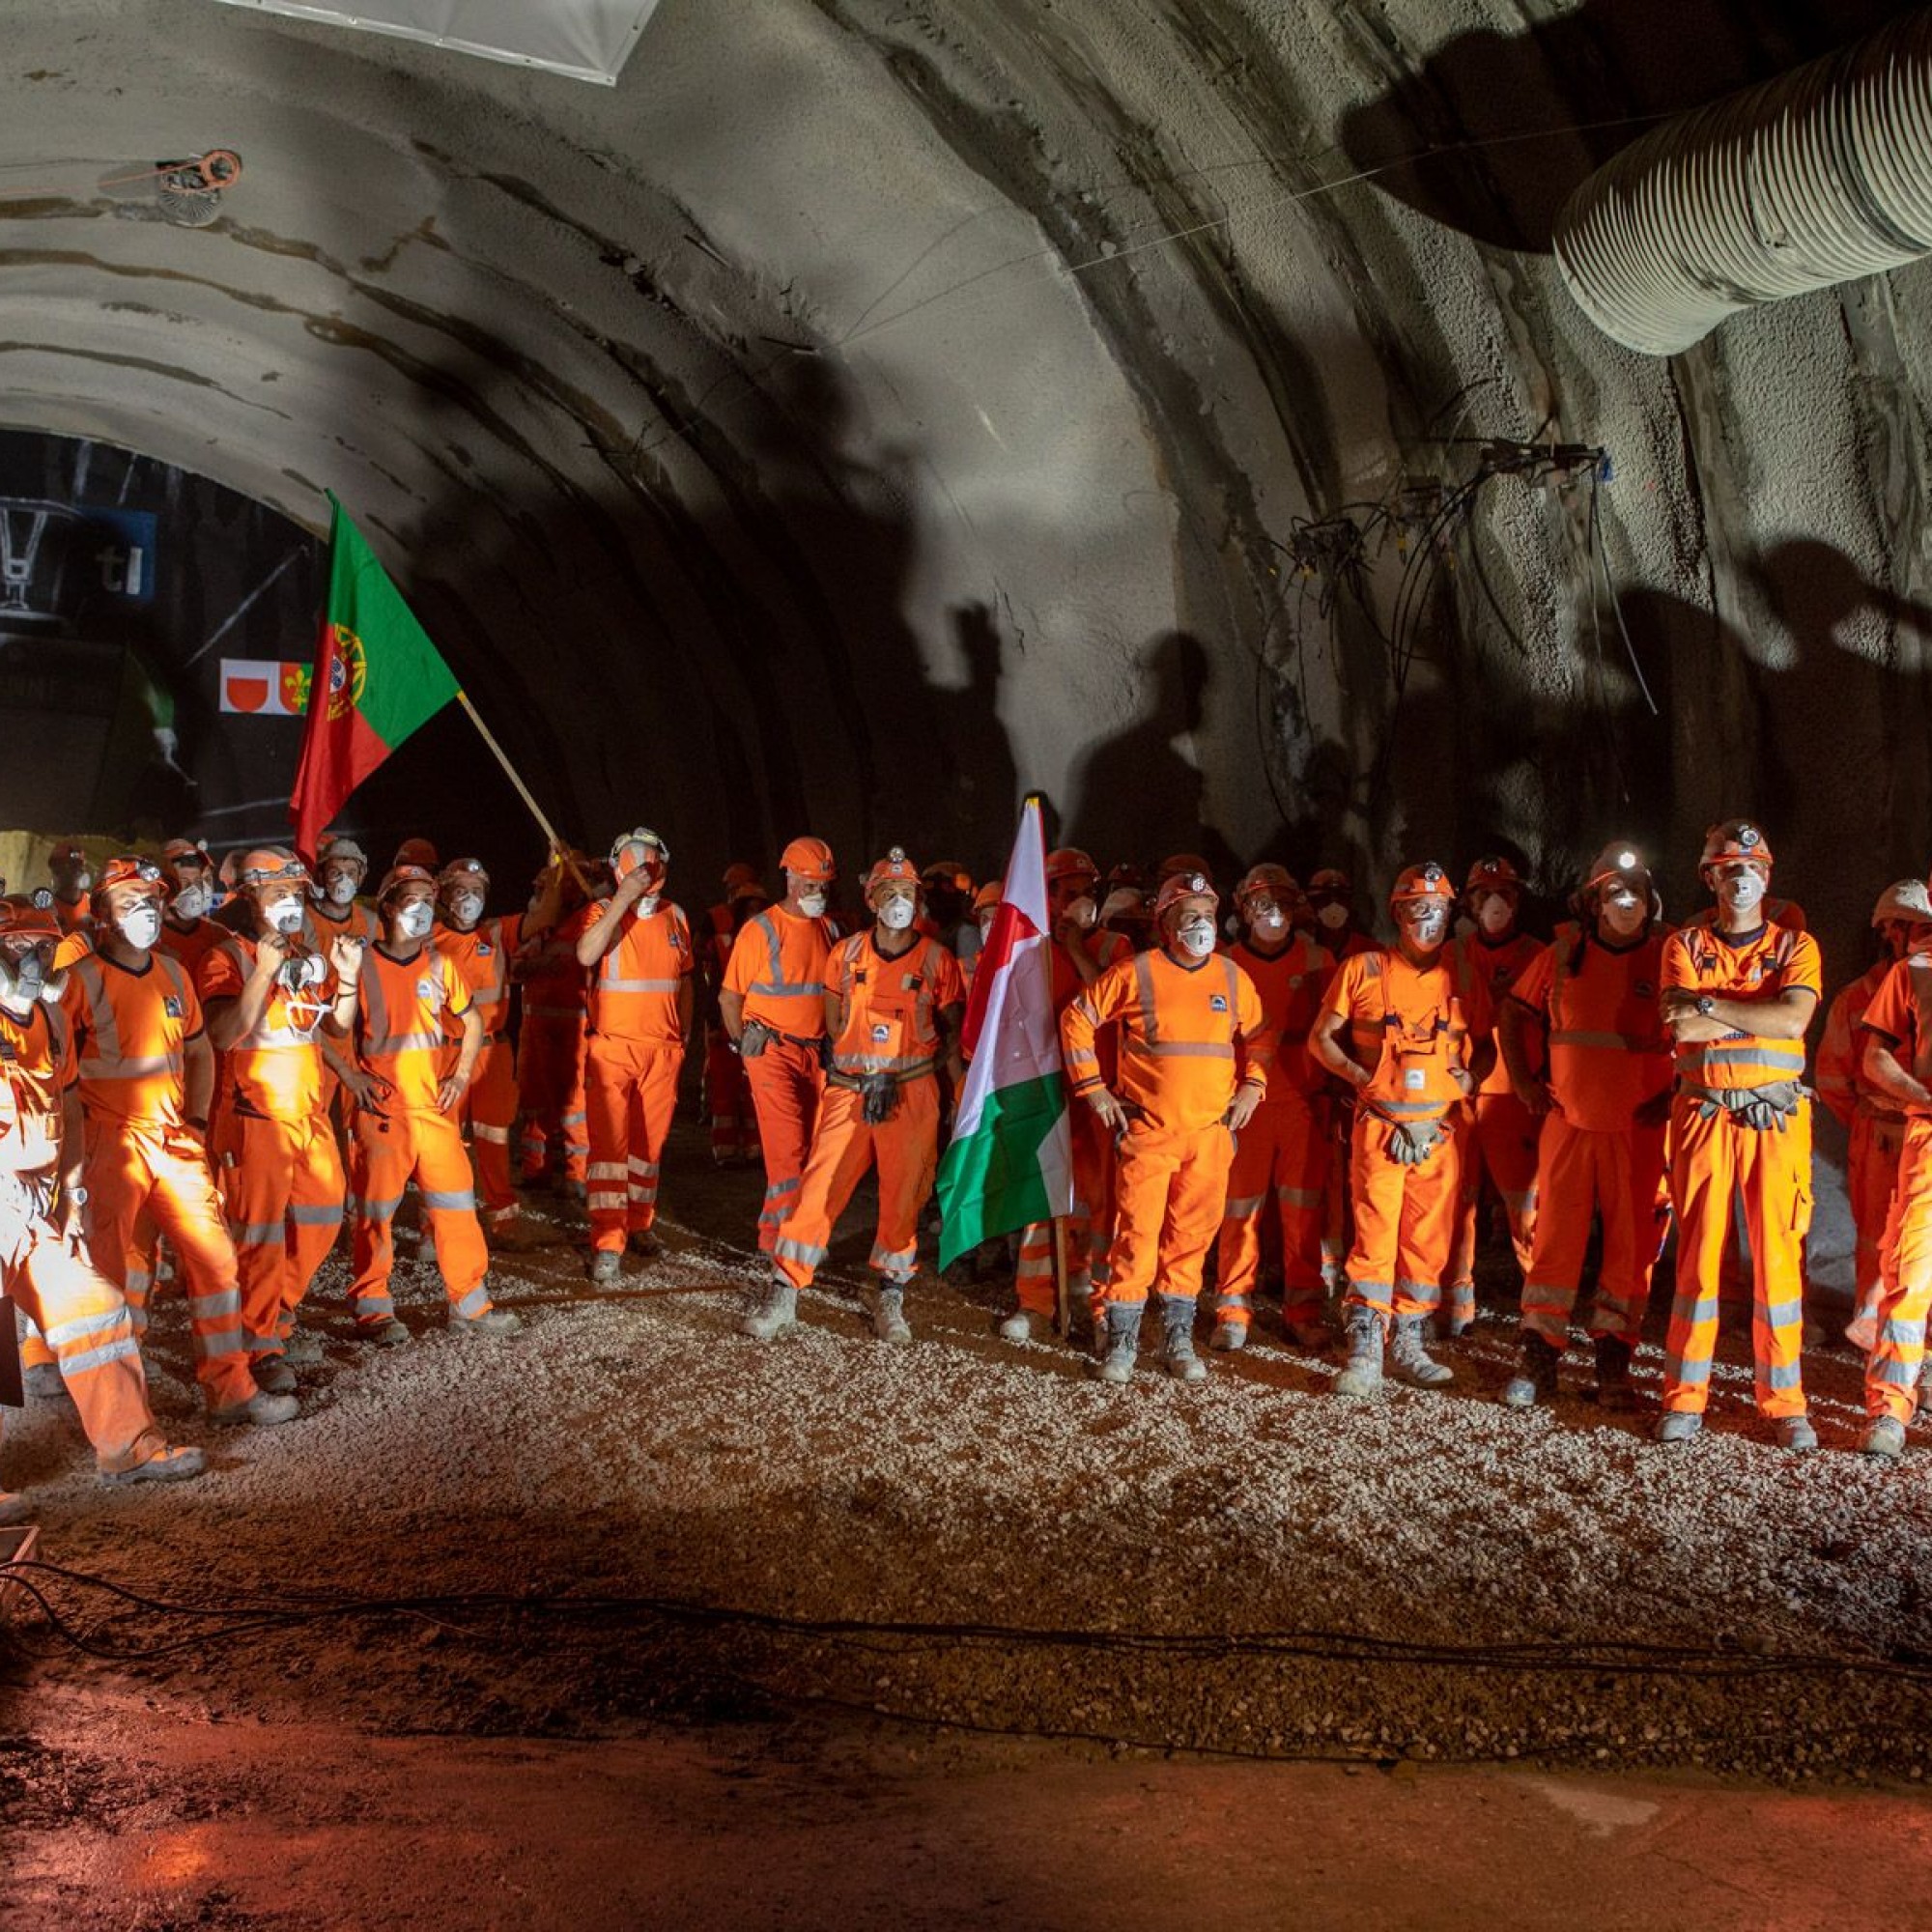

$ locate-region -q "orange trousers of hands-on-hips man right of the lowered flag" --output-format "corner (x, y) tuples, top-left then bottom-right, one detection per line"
(1094, 1121), (1235, 1321)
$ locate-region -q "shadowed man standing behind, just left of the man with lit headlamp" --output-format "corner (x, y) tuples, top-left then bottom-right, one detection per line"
(1447, 856), (1546, 1335)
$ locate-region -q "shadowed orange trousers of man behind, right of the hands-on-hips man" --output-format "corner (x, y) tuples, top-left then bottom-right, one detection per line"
(1215, 1088), (1329, 1327)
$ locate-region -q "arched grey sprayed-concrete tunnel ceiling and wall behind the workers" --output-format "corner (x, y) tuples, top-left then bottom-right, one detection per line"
(0, 0), (1932, 966)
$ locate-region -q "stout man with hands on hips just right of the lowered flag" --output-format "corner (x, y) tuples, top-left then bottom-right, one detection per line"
(1061, 871), (1275, 1383)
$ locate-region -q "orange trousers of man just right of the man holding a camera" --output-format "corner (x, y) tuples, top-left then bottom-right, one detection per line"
(350, 1107), (491, 1327)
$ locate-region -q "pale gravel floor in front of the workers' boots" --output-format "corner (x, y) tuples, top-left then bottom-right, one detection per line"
(4, 1130), (1932, 1777)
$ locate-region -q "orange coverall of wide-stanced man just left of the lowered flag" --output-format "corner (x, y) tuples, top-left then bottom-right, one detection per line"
(771, 931), (966, 1289)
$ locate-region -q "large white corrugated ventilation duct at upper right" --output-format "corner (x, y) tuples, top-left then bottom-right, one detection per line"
(1555, 10), (1932, 355)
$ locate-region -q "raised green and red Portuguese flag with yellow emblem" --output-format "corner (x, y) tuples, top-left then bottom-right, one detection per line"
(288, 491), (460, 860)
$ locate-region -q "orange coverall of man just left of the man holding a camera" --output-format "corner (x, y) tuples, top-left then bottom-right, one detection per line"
(62, 952), (257, 1408)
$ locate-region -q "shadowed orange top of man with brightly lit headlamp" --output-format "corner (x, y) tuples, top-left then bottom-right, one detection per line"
(1509, 925), (1671, 1134)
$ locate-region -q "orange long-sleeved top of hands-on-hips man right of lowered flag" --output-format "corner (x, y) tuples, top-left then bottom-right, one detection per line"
(1061, 947), (1275, 1134)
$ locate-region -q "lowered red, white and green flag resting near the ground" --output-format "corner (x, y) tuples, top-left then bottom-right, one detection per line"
(939, 798), (1074, 1267)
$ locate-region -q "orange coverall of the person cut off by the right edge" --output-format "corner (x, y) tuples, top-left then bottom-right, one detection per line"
(1861, 958), (1932, 1422)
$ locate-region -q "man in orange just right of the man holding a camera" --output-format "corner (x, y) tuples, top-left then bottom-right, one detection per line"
(342, 866), (522, 1347)
